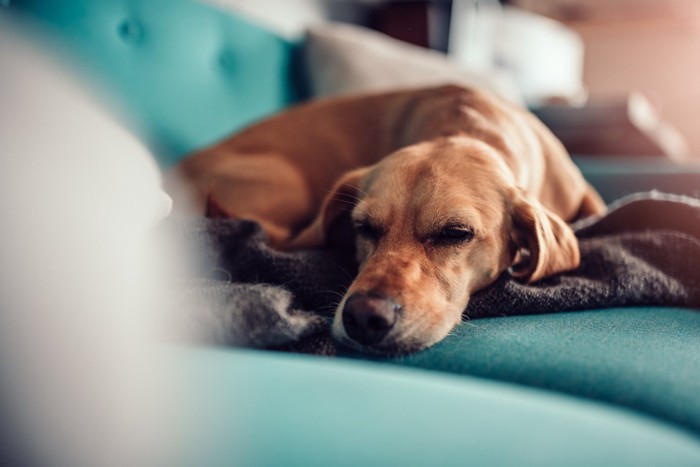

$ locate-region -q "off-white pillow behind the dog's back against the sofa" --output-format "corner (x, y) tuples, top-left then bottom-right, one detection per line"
(304, 23), (521, 103)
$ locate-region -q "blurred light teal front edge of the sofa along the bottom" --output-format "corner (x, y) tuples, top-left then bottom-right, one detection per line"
(172, 348), (700, 467)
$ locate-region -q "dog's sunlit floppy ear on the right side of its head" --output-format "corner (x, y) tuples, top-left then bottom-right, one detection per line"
(511, 195), (581, 283)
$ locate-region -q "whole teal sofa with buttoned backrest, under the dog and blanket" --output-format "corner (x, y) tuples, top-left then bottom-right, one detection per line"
(6, 0), (700, 466)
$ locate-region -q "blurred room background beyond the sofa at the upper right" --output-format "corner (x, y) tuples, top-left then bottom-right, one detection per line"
(207, 0), (700, 160)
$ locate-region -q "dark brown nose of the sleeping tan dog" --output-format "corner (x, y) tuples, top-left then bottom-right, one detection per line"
(343, 292), (401, 345)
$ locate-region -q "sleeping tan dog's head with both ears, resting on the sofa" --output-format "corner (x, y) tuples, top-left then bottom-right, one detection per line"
(300, 139), (579, 353)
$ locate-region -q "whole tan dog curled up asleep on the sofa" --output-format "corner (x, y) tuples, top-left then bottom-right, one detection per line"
(170, 86), (605, 353)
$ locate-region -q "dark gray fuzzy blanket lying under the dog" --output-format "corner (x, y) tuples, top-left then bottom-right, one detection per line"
(167, 192), (700, 354)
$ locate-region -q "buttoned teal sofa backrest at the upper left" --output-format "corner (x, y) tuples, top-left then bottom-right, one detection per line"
(8, 0), (299, 167)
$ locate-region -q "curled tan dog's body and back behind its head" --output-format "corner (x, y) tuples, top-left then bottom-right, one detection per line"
(171, 86), (604, 246)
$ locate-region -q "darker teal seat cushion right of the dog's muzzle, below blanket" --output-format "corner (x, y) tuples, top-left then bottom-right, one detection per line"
(374, 307), (700, 435)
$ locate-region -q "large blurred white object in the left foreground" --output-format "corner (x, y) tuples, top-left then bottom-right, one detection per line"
(0, 16), (174, 466)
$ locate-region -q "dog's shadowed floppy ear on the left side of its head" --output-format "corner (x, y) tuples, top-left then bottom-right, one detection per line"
(289, 167), (370, 249)
